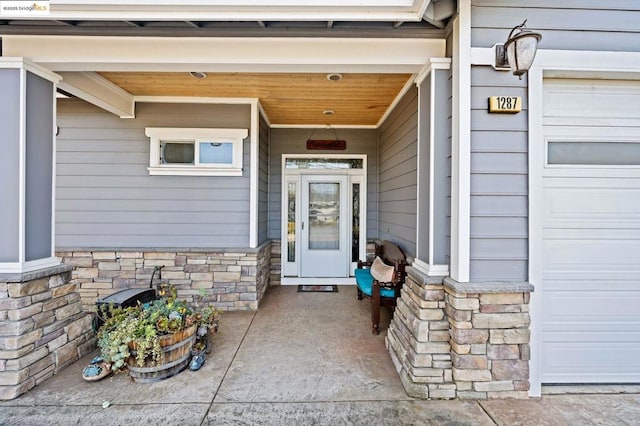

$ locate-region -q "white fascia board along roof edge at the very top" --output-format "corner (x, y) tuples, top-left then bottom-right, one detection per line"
(47, 0), (431, 21)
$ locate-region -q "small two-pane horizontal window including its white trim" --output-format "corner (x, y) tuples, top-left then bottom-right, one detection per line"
(145, 127), (249, 176)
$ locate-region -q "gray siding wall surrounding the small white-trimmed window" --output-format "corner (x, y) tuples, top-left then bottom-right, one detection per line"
(56, 100), (250, 249)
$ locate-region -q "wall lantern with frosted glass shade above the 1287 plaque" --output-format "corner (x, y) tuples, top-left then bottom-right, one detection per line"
(495, 19), (542, 79)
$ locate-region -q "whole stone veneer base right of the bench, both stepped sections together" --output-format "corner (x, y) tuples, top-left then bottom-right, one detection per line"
(386, 268), (533, 399)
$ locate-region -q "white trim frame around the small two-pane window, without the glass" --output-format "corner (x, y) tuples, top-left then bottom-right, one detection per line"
(145, 127), (249, 176)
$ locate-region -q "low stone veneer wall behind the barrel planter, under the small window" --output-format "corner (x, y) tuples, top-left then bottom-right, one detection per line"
(57, 242), (271, 311)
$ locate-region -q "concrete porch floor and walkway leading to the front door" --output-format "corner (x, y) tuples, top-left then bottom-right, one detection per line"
(0, 286), (640, 426)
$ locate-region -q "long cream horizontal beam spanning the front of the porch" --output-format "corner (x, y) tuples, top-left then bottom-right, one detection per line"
(3, 35), (446, 73)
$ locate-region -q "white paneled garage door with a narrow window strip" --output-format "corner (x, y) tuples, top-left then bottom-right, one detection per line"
(541, 79), (640, 383)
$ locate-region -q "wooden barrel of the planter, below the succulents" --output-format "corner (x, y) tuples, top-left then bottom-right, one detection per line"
(127, 325), (196, 383)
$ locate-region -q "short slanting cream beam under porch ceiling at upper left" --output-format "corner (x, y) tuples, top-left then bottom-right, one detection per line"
(58, 72), (135, 118)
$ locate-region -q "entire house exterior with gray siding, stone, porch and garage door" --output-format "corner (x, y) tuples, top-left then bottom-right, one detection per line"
(0, 0), (640, 399)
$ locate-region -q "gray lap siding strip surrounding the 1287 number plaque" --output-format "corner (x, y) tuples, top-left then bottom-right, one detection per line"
(470, 67), (528, 281)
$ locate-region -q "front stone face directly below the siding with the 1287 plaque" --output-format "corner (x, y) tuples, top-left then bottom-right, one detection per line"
(444, 278), (533, 399)
